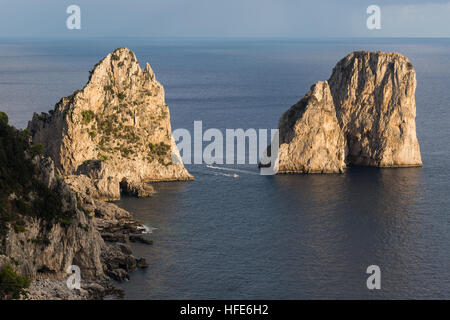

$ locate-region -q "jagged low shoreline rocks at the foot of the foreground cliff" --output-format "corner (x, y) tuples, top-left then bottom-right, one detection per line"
(26, 198), (153, 300)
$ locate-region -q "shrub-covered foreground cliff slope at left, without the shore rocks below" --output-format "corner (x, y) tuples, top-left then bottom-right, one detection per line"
(0, 113), (103, 288)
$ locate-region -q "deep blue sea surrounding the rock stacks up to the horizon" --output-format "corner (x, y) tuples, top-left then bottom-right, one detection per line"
(0, 39), (450, 299)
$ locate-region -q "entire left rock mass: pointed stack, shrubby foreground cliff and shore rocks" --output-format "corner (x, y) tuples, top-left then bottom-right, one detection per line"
(0, 48), (193, 299)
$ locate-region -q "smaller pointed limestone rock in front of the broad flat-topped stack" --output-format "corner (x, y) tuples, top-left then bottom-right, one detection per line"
(279, 82), (345, 173)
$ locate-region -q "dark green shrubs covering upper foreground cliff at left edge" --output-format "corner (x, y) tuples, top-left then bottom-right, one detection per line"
(0, 112), (73, 236)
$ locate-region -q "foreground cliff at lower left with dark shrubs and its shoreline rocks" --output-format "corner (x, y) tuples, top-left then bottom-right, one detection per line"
(0, 112), (151, 299)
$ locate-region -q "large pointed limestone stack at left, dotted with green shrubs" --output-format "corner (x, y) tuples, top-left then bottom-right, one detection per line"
(28, 48), (192, 200)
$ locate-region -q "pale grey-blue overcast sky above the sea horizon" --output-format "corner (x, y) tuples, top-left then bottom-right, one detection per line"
(0, 0), (450, 38)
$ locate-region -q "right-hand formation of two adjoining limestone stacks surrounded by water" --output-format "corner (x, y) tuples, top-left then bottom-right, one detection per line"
(279, 52), (422, 173)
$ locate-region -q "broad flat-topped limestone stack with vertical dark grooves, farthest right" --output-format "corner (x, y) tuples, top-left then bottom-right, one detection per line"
(328, 52), (422, 167)
